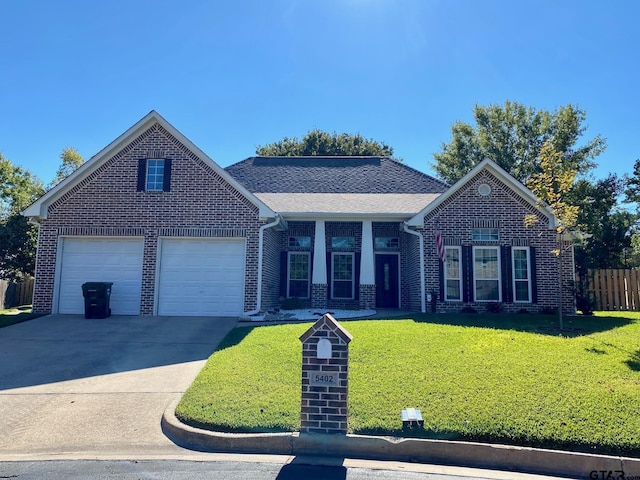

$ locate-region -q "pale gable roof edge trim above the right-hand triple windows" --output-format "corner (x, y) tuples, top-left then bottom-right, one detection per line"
(407, 158), (557, 227)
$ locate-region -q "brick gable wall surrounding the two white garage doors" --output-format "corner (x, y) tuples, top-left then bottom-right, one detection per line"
(34, 124), (261, 315)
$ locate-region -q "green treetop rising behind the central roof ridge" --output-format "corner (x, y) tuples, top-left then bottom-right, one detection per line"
(256, 129), (393, 157)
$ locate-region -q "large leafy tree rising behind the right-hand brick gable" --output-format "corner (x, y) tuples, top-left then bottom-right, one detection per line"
(433, 100), (606, 183)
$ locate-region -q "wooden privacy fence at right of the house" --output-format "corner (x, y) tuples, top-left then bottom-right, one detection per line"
(580, 268), (640, 312)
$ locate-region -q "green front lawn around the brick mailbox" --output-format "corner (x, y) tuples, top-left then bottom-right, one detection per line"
(176, 312), (640, 456)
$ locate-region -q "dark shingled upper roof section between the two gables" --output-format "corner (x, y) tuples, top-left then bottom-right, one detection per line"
(225, 157), (449, 194)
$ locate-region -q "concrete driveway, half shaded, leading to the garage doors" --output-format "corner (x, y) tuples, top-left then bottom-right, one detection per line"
(0, 315), (237, 459)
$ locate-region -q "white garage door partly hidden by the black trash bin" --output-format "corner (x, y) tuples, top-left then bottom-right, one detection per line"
(58, 237), (144, 315)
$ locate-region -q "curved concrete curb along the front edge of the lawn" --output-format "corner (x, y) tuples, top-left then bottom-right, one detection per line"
(162, 400), (640, 478)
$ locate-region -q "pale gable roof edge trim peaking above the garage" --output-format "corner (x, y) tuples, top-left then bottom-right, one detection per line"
(22, 110), (276, 219)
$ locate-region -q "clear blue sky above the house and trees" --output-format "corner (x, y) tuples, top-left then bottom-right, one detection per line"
(0, 0), (640, 183)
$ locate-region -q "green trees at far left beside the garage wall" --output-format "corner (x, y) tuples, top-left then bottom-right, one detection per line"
(0, 153), (44, 279)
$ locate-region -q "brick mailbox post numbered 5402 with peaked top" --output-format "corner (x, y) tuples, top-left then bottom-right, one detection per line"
(300, 313), (353, 435)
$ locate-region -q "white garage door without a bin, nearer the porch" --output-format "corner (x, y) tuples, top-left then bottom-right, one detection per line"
(157, 238), (245, 316)
